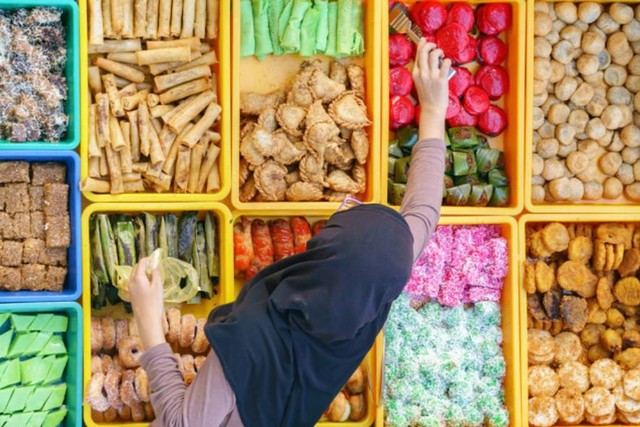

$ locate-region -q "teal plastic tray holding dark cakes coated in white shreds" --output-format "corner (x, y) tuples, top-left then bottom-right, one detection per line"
(0, 0), (80, 150)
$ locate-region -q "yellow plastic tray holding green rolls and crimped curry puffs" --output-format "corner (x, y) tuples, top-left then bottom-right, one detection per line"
(231, 0), (386, 213)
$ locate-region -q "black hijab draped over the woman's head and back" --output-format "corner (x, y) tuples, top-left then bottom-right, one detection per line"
(205, 205), (413, 427)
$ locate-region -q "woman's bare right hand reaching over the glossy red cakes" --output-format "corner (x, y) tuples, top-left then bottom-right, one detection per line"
(413, 39), (451, 139)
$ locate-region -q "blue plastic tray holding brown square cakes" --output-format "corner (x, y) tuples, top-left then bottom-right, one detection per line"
(0, 150), (82, 303)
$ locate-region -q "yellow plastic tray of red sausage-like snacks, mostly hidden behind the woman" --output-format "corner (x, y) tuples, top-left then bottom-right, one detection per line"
(231, 210), (380, 427)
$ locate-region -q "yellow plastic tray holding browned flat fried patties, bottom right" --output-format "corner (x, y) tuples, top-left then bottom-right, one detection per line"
(517, 212), (640, 427)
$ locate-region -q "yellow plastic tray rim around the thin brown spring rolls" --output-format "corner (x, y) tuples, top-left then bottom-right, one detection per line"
(78, 0), (231, 203)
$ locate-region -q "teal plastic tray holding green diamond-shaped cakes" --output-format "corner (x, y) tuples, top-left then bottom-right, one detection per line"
(0, 302), (82, 427)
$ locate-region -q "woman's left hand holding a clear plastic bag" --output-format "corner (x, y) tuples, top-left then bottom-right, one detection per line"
(129, 258), (166, 349)
